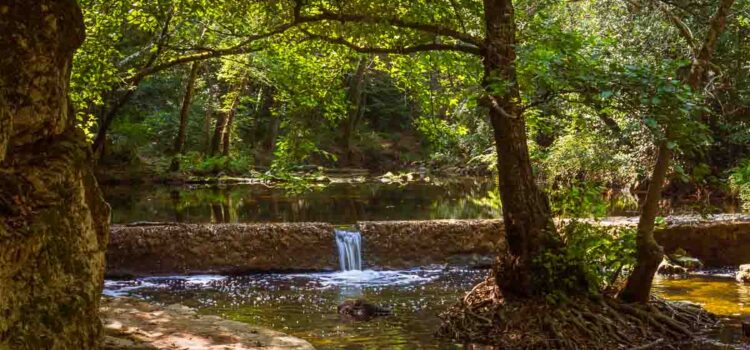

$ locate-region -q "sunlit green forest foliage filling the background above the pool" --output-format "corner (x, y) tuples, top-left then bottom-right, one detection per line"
(72, 0), (750, 211)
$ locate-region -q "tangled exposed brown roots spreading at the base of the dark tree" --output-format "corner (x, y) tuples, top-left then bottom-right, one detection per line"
(438, 279), (719, 349)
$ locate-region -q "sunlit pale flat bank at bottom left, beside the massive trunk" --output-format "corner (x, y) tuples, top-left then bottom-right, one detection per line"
(100, 297), (314, 350)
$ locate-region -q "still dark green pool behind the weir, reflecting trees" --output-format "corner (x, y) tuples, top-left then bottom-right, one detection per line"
(104, 178), (748, 224)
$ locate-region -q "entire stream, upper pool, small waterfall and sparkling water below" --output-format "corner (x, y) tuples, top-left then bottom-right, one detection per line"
(104, 178), (750, 349)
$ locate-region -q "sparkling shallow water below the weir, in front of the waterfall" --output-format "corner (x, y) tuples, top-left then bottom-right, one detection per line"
(107, 268), (750, 349)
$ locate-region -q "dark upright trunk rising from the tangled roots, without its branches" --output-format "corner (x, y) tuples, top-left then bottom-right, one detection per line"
(483, 0), (562, 297)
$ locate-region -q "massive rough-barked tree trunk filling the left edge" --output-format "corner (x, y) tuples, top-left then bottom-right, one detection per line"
(0, 0), (109, 349)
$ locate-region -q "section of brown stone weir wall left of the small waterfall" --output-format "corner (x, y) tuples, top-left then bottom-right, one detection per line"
(107, 223), (338, 277)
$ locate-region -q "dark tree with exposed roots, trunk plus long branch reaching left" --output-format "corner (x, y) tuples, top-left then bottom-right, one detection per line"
(298, 0), (588, 298)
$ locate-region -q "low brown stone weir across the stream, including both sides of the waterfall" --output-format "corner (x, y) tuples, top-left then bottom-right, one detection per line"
(107, 216), (750, 277)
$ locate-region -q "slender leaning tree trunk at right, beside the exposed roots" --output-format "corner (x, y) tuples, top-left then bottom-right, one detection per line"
(619, 0), (735, 303)
